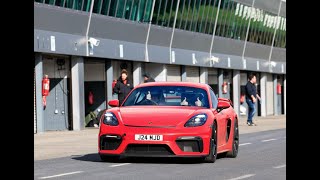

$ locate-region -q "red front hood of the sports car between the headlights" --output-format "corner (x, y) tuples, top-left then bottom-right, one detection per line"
(119, 106), (202, 127)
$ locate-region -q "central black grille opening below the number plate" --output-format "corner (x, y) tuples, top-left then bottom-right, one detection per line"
(125, 144), (174, 155)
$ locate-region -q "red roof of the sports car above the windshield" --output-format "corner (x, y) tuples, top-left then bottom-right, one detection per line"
(135, 81), (209, 89)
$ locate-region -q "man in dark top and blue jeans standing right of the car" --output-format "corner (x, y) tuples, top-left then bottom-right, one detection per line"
(246, 74), (261, 126)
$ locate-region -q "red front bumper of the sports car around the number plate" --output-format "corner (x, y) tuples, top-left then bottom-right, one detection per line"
(98, 126), (212, 157)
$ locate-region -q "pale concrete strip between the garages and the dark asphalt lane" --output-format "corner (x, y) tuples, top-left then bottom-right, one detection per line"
(34, 115), (286, 161)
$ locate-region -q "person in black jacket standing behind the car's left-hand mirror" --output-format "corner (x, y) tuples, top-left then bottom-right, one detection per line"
(113, 70), (133, 105)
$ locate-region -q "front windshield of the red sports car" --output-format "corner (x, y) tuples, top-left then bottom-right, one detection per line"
(123, 86), (210, 108)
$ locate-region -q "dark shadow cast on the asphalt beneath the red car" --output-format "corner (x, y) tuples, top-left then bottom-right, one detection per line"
(72, 153), (225, 164)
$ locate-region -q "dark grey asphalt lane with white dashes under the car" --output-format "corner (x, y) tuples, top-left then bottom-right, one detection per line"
(34, 129), (286, 180)
